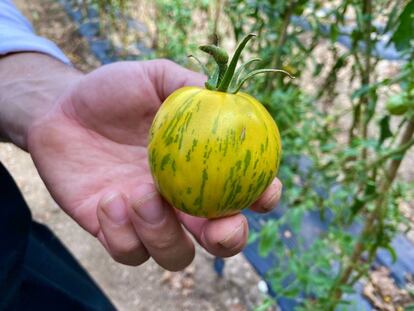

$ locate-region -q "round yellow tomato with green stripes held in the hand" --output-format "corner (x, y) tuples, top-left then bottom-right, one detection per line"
(148, 87), (281, 218)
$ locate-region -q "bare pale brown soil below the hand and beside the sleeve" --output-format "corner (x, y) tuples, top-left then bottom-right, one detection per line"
(0, 0), (272, 311)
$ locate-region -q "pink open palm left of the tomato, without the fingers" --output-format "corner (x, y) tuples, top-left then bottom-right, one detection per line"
(30, 63), (171, 235)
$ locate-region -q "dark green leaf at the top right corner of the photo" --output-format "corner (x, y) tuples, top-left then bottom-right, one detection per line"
(391, 0), (414, 51)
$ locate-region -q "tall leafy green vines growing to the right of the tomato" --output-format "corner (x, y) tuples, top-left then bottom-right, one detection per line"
(220, 0), (414, 310)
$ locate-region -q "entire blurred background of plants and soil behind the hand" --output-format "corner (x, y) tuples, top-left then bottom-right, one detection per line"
(0, 0), (414, 311)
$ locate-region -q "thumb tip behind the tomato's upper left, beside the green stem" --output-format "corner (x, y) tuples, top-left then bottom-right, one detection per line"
(143, 59), (207, 101)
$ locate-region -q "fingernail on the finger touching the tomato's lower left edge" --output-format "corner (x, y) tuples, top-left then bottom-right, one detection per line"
(133, 192), (165, 224)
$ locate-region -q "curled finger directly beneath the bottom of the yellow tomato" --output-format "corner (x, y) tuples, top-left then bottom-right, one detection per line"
(177, 211), (249, 257)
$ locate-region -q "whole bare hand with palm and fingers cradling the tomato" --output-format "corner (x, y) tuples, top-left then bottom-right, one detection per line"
(28, 61), (281, 270)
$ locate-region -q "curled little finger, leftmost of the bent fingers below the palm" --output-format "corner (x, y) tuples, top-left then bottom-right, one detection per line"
(97, 192), (149, 266)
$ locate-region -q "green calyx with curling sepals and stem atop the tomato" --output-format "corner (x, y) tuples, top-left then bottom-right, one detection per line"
(189, 34), (294, 94)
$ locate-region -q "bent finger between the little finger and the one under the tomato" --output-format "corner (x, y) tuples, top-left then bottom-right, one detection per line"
(128, 184), (195, 271)
